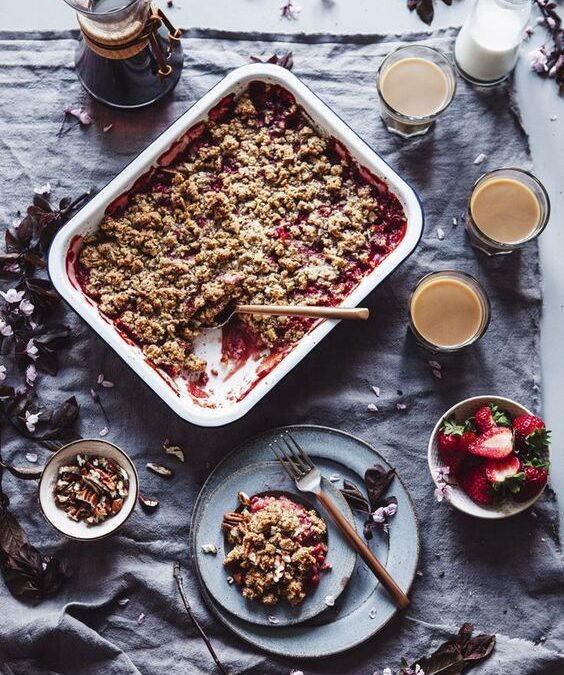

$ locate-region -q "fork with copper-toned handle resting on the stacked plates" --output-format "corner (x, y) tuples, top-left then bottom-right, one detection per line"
(269, 431), (409, 609)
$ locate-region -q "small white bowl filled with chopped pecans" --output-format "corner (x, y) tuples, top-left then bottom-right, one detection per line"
(39, 439), (139, 541)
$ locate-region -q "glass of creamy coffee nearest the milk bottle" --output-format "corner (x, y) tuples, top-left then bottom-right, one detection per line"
(376, 45), (456, 138)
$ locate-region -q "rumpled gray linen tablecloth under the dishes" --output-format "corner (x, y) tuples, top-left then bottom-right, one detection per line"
(0, 26), (564, 675)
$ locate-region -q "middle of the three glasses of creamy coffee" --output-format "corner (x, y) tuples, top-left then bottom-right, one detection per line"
(466, 168), (550, 255)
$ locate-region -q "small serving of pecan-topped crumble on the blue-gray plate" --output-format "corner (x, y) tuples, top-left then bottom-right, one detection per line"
(223, 496), (330, 606)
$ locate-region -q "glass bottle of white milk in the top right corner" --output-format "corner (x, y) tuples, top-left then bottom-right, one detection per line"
(454, 0), (531, 86)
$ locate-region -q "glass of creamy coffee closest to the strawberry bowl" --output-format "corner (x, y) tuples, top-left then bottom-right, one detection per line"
(409, 270), (490, 352)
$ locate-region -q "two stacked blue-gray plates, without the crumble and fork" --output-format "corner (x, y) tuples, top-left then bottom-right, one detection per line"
(190, 426), (419, 658)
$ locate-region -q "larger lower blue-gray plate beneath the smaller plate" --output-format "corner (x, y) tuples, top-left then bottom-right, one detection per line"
(190, 426), (419, 658)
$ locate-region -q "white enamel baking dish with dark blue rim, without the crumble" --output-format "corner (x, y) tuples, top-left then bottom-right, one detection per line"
(49, 64), (423, 426)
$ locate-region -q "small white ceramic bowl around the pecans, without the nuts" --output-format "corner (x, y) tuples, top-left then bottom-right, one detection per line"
(39, 439), (139, 541)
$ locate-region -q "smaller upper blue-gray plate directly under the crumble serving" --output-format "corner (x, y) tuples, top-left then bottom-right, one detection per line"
(193, 461), (356, 626)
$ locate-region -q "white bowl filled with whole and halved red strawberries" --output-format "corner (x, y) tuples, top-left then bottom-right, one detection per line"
(428, 396), (550, 518)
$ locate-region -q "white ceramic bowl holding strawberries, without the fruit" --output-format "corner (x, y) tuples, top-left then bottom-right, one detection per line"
(427, 396), (550, 519)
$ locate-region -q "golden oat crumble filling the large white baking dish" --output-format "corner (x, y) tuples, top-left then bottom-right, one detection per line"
(78, 83), (405, 375)
